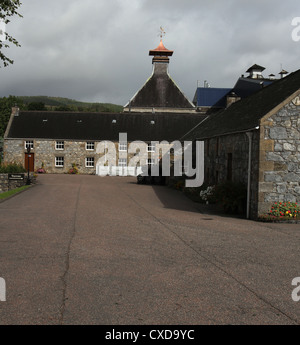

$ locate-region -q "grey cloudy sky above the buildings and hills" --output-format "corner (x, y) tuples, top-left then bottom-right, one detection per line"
(0, 0), (300, 105)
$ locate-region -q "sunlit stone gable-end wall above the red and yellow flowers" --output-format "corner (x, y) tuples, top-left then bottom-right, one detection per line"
(258, 97), (300, 214)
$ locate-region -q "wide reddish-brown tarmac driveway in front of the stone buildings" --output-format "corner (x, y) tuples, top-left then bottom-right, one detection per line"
(0, 175), (300, 325)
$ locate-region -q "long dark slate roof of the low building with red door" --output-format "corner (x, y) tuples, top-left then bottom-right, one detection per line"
(6, 111), (204, 142)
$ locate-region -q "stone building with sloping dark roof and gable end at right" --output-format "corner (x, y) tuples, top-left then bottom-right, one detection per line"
(183, 70), (300, 219)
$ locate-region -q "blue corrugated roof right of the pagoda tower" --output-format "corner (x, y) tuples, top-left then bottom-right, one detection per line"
(194, 87), (232, 107)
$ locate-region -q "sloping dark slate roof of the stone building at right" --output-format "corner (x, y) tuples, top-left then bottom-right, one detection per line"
(182, 70), (300, 140)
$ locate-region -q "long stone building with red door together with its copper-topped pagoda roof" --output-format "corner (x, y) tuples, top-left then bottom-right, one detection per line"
(4, 41), (205, 174)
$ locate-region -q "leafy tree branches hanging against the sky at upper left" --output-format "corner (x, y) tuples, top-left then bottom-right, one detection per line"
(0, 0), (22, 68)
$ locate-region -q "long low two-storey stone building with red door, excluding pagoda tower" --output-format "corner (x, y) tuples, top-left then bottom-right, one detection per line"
(4, 108), (199, 174)
